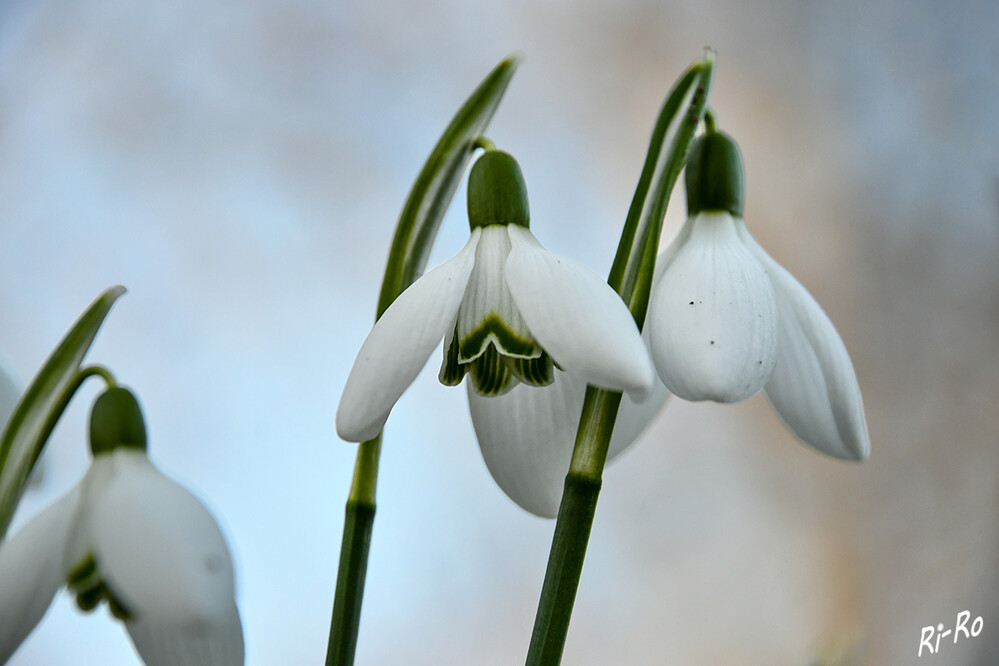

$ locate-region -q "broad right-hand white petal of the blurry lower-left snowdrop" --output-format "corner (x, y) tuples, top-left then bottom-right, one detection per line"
(90, 449), (243, 666)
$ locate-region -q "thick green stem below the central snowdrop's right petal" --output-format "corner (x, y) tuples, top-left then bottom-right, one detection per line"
(527, 386), (621, 666)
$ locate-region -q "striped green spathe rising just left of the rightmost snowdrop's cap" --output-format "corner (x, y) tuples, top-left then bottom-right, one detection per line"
(607, 50), (715, 328)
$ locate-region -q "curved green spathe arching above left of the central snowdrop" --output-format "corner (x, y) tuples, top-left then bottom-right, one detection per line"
(378, 55), (520, 317)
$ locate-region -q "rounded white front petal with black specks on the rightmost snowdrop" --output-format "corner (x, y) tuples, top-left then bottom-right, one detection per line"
(646, 213), (777, 402)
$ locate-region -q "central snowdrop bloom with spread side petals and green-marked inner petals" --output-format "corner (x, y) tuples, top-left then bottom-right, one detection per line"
(336, 150), (655, 442)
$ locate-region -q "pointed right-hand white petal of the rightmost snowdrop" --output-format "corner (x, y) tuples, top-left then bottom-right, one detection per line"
(742, 230), (871, 460)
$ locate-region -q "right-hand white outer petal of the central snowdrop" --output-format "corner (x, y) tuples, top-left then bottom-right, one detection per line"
(506, 225), (655, 398)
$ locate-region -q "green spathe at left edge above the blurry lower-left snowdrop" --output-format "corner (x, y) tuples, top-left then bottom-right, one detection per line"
(0, 286), (125, 541)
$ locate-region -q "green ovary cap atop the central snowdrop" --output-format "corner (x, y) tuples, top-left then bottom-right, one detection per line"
(468, 150), (531, 229)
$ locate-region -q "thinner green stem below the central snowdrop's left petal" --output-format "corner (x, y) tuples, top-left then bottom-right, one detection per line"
(326, 434), (382, 666)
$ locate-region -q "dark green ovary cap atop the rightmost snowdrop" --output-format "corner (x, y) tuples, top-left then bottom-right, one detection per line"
(684, 132), (746, 217)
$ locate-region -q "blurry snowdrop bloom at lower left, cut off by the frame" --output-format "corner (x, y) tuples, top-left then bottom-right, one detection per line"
(0, 388), (243, 666)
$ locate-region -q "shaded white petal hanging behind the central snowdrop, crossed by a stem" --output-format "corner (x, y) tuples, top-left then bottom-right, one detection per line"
(468, 371), (668, 518)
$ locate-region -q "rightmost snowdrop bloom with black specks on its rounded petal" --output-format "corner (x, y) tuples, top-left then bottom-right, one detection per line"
(647, 131), (870, 460)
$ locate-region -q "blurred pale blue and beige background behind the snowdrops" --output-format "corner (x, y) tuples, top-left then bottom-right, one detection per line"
(0, 0), (999, 666)
